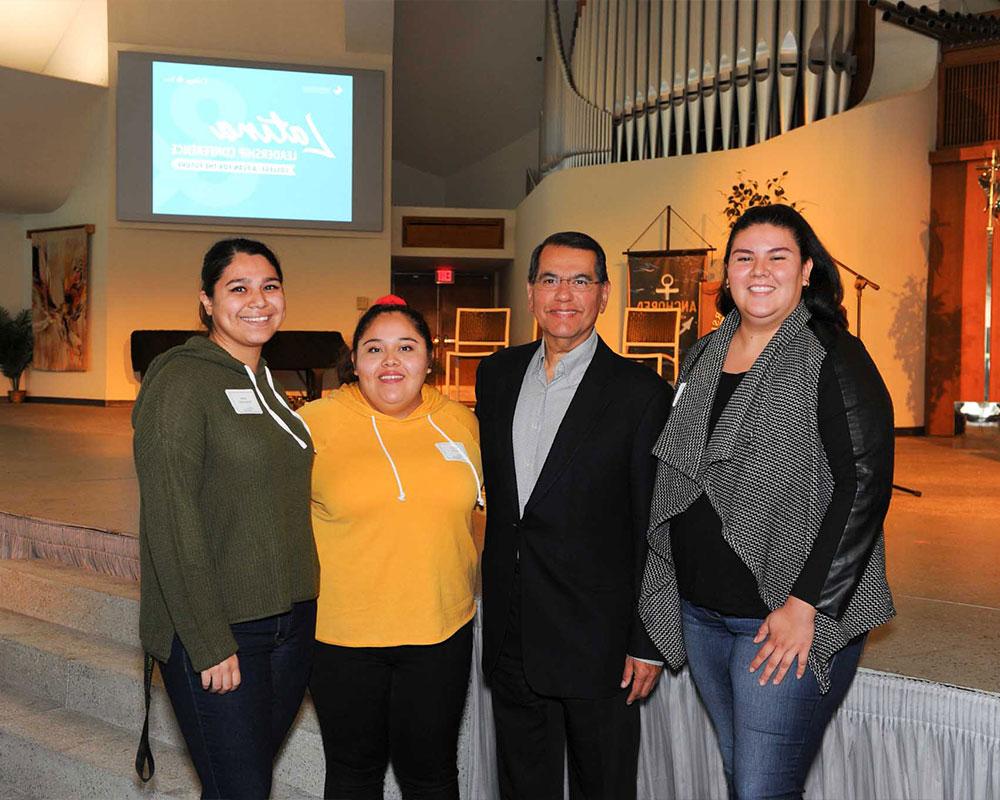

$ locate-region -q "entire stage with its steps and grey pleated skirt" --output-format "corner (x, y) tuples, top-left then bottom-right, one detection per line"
(0, 404), (1000, 800)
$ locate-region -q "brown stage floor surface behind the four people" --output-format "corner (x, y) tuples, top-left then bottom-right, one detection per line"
(0, 403), (1000, 692)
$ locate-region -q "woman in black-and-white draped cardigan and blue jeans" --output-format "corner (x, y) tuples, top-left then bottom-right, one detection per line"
(640, 205), (895, 800)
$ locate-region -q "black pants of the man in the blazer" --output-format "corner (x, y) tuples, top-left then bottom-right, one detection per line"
(490, 576), (639, 800)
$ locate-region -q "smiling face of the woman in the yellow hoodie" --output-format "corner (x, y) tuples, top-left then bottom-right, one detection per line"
(351, 312), (430, 419)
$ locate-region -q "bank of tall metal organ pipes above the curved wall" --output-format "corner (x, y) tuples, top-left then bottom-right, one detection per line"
(539, 0), (864, 175)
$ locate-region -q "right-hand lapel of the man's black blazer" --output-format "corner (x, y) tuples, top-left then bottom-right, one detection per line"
(524, 339), (615, 514)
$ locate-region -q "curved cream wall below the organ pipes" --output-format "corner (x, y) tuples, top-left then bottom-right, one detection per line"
(509, 85), (936, 427)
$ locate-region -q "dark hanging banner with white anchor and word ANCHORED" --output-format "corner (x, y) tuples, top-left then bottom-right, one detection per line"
(627, 248), (722, 359)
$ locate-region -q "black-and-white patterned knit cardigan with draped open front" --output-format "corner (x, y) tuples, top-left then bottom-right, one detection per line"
(639, 304), (895, 692)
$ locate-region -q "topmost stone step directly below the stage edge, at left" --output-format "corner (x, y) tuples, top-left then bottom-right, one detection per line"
(0, 561), (139, 645)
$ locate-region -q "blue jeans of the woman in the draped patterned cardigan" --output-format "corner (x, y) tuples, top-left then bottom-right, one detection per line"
(681, 601), (865, 800)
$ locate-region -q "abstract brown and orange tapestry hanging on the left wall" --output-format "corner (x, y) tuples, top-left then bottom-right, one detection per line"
(29, 225), (93, 372)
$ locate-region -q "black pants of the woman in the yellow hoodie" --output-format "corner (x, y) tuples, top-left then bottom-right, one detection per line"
(309, 622), (472, 800)
